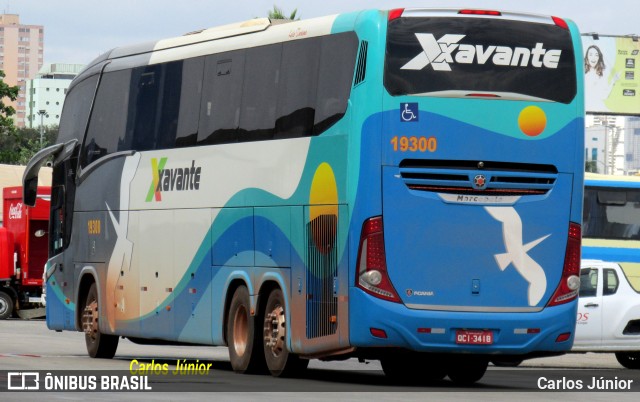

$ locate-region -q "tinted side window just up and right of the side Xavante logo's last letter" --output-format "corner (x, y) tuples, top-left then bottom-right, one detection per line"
(198, 50), (245, 144)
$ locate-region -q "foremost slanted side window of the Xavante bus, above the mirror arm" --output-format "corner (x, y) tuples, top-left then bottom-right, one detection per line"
(57, 75), (98, 143)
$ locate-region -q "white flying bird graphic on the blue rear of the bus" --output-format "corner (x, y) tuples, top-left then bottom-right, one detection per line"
(485, 207), (551, 306)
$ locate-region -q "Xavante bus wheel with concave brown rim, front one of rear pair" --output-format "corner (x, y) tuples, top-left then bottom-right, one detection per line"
(227, 286), (264, 373)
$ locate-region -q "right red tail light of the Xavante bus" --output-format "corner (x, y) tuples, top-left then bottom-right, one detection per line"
(548, 222), (582, 306)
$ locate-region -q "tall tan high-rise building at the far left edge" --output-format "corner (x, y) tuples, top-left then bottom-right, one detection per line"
(0, 14), (44, 127)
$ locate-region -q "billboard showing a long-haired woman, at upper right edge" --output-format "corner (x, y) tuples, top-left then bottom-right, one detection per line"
(582, 34), (640, 115)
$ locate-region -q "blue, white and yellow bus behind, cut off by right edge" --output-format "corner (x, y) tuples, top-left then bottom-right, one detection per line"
(582, 173), (640, 291)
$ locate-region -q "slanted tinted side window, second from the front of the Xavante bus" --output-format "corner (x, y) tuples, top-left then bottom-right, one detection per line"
(80, 70), (131, 167)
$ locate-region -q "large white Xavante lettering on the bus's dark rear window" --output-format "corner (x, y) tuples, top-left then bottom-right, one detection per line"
(400, 33), (562, 71)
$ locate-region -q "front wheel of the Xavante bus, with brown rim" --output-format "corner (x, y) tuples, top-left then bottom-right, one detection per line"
(82, 283), (119, 359)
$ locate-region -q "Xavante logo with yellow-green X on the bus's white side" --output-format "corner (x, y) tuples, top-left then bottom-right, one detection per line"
(146, 157), (202, 202)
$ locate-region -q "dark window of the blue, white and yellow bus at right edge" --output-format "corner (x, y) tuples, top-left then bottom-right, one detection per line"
(583, 187), (640, 240)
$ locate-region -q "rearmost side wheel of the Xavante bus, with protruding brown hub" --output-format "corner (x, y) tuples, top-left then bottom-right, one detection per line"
(264, 289), (309, 377)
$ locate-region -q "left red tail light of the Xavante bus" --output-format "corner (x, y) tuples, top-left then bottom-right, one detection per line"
(356, 216), (400, 303)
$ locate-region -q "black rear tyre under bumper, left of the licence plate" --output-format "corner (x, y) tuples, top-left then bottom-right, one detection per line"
(380, 354), (447, 384)
